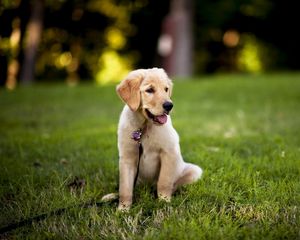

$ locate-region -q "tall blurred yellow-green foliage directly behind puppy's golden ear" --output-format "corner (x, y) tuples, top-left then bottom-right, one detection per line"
(89, 0), (145, 83)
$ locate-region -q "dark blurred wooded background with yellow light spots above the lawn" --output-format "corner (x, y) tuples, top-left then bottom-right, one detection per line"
(0, 0), (300, 89)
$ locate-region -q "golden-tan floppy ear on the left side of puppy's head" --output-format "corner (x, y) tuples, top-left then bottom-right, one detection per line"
(116, 69), (146, 111)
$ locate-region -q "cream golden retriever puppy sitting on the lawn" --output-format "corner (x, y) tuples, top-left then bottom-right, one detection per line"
(103, 68), (202, 211)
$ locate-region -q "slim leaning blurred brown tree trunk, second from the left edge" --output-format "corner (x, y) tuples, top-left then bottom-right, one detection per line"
(20, 0), (44, 84)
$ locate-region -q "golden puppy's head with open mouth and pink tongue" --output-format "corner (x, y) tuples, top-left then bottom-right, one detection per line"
(117, 68), (173, 125)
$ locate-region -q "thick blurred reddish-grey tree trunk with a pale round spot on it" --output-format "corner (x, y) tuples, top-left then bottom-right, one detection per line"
(159, 0), (193, 77)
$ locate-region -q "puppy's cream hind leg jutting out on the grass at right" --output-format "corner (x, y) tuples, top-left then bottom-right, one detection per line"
(174, 163), (203, 191)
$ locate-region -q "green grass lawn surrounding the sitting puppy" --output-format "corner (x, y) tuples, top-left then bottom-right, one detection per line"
(0, 73), (300, 239)
